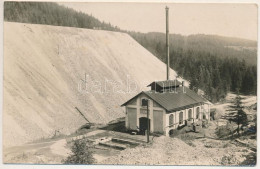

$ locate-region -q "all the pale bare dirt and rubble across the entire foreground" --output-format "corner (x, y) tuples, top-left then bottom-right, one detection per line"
(4, 121), (256, 165)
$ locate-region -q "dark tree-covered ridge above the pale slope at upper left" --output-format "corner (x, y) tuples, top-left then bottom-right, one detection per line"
(4, 2), (120, 31)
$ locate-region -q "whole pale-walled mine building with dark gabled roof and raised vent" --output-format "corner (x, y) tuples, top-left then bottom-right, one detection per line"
(122, 80), (210, 136)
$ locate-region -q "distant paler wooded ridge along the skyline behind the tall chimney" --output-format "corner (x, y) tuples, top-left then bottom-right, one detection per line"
(130, 32), (257, 65)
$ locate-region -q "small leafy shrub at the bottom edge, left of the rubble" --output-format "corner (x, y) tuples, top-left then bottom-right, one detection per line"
(64, 139), (95, 164)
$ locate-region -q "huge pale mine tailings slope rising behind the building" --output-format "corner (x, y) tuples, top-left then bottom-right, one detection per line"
(3, 22), (179, 146)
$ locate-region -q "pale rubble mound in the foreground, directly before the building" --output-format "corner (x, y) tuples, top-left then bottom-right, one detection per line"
(101, 122), (254, 165)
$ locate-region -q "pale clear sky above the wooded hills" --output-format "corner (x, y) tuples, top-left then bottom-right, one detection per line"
(59, 2), (258, 40)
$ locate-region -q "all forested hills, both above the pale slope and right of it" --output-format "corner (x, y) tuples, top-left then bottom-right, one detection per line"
(4, 2), (257, 102)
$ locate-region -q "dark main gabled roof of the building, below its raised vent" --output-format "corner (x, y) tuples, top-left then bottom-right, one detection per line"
(122, 87), (206, 111)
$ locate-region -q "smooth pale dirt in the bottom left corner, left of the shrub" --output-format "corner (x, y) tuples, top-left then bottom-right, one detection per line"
(3, 130), (105, 164)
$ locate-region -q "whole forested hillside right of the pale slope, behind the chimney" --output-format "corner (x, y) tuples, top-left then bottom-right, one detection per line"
(130, 32), (257, 102)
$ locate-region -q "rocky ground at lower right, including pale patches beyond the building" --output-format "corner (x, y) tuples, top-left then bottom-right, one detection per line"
(101, 94), (257, 166)
